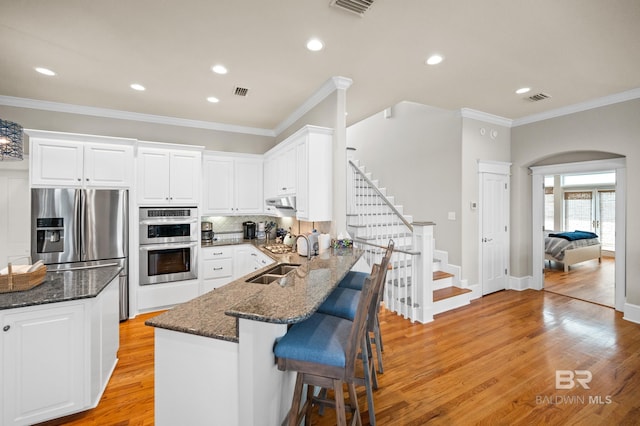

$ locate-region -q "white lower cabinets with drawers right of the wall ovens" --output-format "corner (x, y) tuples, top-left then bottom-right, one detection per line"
(201, 244), (275, 294)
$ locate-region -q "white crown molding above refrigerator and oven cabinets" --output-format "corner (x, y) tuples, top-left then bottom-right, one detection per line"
(0, 95), (276, 137)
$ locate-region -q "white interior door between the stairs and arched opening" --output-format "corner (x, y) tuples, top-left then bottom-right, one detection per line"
(480, 168), (509, 295)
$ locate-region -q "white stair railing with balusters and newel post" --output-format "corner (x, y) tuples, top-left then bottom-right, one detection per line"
(347, 160), (433, 323)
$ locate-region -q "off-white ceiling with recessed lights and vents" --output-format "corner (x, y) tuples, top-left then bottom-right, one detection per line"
(0, 0), (640, 129)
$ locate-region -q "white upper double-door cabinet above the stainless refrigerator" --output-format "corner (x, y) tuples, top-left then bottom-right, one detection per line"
(30, 135), (133, 188)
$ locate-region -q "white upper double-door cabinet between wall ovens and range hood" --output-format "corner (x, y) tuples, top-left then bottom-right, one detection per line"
(203, 154), (264, 215)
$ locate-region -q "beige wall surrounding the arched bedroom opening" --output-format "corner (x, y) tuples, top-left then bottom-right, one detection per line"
(511, 99), (640, 305)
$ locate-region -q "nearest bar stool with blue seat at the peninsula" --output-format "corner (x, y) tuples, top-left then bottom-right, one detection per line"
(274, 268), (382, 426)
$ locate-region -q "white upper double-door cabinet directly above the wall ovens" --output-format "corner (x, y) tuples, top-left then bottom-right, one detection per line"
(137, 146), (202, 206)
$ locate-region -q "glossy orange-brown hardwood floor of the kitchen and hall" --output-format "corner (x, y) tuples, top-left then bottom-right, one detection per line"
(36, 290), (640, 426)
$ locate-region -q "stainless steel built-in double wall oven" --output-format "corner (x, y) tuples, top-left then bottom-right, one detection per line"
(140, 207), (199, 285)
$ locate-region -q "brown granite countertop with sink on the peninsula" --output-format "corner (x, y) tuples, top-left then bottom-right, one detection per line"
(145, 249), (363, 342)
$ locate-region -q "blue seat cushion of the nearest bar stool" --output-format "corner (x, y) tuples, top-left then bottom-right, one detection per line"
(273, 312), (353, 367)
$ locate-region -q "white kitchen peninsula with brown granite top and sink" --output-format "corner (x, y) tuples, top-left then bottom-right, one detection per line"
(146, 249), (362, 426)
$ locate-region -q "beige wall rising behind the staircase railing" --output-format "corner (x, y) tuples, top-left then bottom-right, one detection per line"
(347, 102), (462, 265)
